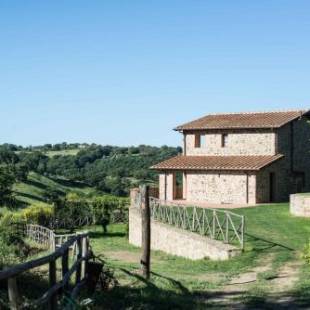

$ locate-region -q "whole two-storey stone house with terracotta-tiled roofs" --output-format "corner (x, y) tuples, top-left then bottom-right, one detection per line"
(151, 111), (310, 204)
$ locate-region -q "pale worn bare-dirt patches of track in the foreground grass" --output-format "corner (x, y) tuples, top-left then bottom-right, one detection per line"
(105, 250), (301, 310)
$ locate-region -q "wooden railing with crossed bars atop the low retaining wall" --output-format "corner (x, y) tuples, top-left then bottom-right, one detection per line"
(150, 197), (245, 249)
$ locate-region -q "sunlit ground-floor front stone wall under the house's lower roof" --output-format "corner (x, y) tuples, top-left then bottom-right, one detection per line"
(186, 171), (256, 204)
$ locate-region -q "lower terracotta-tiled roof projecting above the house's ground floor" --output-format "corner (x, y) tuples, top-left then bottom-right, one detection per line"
(151, 154), (283, 170)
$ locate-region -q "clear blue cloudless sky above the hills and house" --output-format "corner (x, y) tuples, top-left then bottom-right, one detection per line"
(0, 0), (310, 145)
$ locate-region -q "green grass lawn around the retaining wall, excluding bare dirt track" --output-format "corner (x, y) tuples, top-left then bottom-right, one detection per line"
(86, 204), (310, 309)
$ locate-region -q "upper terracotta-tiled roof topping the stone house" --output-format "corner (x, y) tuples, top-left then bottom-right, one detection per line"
(175, 110), (309, 131)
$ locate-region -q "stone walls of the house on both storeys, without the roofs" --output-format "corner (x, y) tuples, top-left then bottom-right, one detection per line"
(159, 117), (310, 204)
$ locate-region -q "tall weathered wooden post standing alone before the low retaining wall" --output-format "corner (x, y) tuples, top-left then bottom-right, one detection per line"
(140, 185), (151, 279)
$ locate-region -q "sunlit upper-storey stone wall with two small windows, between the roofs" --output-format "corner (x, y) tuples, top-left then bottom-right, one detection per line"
(185, 130), (276, 156)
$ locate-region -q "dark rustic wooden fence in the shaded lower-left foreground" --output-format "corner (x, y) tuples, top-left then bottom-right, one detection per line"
(0, 227), (91, 310)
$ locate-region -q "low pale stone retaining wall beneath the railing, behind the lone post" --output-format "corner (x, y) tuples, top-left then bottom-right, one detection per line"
(129, 207), (241, 260)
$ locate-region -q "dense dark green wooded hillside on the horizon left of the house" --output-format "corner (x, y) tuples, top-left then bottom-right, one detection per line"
(0, 144), (182, 196)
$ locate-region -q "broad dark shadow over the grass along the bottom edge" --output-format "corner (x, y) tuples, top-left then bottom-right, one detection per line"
(94, 268), (309, 309)
